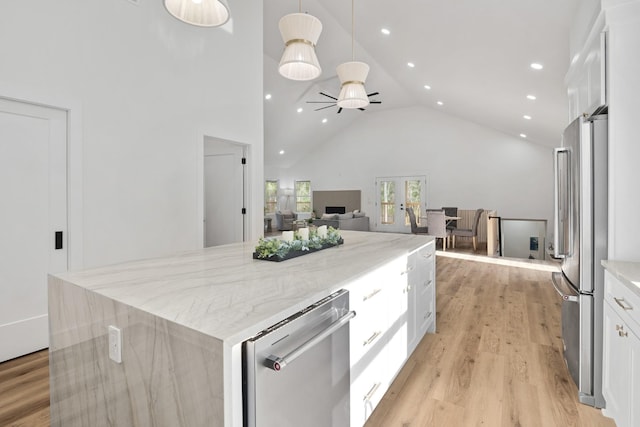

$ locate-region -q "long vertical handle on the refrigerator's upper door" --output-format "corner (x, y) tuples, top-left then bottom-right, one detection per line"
(553, 147), (573, 258)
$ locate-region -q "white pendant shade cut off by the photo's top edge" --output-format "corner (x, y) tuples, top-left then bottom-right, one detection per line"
(164, 0), (229, 27)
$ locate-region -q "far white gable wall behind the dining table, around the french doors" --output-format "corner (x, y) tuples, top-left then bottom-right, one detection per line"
(265, 107), (560, 236)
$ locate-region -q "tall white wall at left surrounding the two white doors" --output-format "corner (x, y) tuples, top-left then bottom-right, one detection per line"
(0, 0), (263, 268)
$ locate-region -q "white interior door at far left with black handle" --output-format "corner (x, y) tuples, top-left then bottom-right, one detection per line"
(0, 98), (67, 362)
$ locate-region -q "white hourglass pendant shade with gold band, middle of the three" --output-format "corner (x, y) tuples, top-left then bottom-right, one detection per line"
(278, 13), (322, 80)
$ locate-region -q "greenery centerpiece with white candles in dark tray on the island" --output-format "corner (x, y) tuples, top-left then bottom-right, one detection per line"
(253, 225), (344, 262)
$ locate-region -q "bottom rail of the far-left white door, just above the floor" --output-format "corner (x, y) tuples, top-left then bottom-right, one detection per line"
(0, 314), (49, 362)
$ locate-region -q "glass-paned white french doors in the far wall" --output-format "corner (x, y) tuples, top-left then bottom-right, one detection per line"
(376, 175), (427, 233)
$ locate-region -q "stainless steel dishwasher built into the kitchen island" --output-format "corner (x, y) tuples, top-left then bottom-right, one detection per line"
(243, 290), (355, 427)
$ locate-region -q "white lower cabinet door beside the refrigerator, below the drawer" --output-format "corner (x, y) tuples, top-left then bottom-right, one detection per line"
(602, 302), (637, 427)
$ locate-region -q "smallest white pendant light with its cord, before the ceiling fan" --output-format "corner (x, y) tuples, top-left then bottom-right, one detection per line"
(336, 0), (369, 108)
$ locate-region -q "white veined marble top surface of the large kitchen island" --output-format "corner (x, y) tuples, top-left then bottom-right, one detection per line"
(56, 231), (433, 345)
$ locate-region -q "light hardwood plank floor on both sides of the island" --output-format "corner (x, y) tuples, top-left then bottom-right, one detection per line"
(0, 252), (615, 427)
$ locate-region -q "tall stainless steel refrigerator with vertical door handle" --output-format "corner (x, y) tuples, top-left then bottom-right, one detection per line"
(552, 112), (608, 408)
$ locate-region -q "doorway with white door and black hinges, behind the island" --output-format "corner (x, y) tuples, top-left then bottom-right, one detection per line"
(203, 137), (247, 247)
